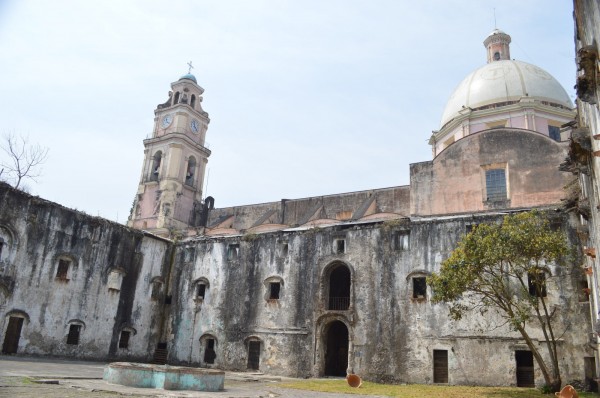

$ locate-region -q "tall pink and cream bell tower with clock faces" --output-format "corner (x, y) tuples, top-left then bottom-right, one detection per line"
(127, 67), (210, 236)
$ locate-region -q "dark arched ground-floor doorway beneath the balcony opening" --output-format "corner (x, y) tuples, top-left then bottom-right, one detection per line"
(323, 321), (348, 377)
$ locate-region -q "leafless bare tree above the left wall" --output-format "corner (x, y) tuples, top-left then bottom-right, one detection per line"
(0, 133), (48, 188)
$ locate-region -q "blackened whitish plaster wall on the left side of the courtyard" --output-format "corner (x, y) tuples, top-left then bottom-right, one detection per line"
(0, 184), (170, 360)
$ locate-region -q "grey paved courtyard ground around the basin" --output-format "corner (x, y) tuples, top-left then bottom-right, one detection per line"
(0, 356), (382, 398)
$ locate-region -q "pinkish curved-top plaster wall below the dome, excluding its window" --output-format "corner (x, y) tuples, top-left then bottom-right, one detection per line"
(410, 129), (572, 216)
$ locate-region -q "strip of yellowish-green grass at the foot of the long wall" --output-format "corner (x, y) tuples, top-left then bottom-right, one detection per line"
(277, 380), (598, 398)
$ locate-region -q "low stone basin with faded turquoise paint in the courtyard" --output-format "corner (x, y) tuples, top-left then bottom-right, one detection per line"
(103, 362), (225, 391)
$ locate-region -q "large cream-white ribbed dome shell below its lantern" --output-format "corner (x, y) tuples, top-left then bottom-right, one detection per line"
(441, 59), (573, 127)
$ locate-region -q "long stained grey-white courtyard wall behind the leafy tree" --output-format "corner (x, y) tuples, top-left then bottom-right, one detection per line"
(164, 214), (590, 385)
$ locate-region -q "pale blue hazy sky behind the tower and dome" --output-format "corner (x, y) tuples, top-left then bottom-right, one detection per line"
(0, 0), (576, 223)
